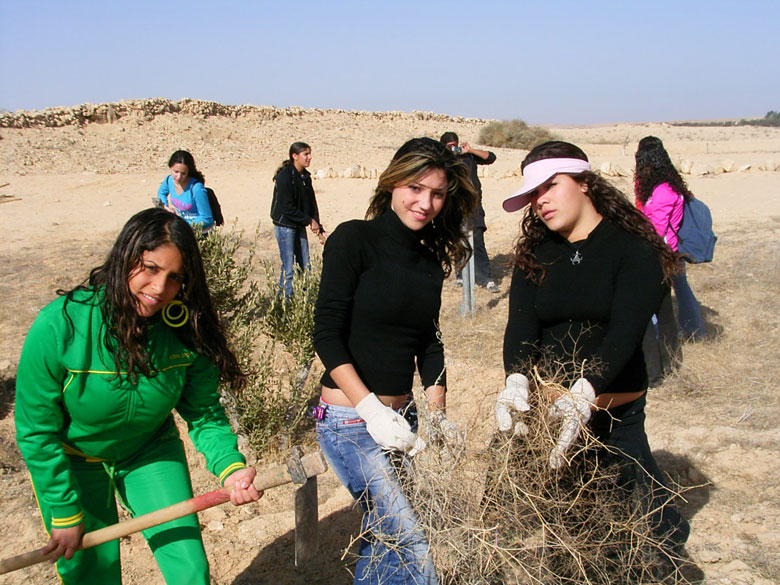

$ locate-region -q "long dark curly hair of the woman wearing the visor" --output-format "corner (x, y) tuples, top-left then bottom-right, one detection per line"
(512, 140), (679, 284)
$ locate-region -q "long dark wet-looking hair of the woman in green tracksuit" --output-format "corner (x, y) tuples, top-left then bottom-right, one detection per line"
(58, 208), (246, 389)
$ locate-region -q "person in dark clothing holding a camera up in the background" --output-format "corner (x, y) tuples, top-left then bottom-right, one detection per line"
(439, 132), (499, 292)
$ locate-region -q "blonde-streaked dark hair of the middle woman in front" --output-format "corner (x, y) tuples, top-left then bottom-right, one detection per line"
(366, 138), (477, 276)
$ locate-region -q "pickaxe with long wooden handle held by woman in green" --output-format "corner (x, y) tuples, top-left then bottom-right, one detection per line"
(0, 447), (328, 575)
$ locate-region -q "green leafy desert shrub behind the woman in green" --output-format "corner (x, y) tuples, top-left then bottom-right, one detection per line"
(201, 228), (320, 455)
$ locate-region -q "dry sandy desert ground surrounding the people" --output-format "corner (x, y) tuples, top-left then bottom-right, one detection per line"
(0, 105), (780, 585)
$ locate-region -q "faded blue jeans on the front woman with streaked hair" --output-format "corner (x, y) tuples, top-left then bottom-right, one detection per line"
(317, 402), (438, 585)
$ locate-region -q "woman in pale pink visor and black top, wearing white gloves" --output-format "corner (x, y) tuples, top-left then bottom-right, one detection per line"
(496, 141), (689, 572)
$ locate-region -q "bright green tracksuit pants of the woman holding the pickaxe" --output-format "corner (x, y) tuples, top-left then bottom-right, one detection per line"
(36, 436), (210, 585)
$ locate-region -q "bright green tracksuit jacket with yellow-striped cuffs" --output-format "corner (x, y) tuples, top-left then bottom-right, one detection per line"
(15, 291), (245, 528)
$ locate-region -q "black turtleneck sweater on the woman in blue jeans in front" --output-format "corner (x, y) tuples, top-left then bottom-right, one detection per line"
(314, 210), (446, 396)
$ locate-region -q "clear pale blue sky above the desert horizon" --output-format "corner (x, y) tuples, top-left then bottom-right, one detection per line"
(0, 0), (780, 124)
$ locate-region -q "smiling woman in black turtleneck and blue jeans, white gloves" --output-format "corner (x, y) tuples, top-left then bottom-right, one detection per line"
(314, 138), (476, 585)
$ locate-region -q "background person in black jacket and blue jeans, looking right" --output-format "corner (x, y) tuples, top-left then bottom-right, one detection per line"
(271, 142), (325, 298)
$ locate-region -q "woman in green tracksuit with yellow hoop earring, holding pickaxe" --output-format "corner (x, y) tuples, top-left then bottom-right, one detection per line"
(15, 209), (262, 585)
